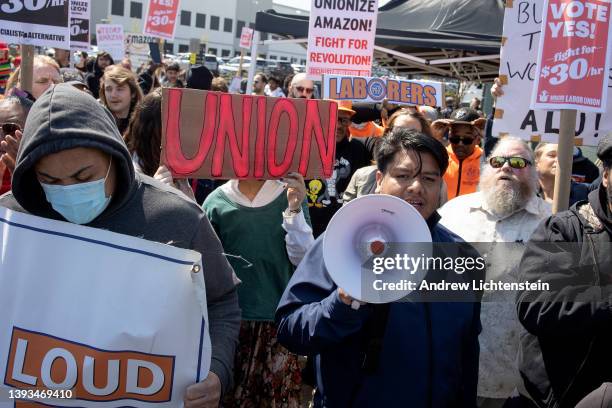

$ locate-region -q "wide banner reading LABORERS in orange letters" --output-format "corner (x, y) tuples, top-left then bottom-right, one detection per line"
(323, 75), (444, 106)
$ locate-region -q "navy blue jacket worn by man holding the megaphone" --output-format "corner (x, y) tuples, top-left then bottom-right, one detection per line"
(276, 214), (480, 408)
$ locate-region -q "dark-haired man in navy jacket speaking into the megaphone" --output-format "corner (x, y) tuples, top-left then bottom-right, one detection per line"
(276, 128), (480, 408)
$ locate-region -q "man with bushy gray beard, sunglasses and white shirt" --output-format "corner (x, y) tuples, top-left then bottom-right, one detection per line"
(439, 138), (551, 408)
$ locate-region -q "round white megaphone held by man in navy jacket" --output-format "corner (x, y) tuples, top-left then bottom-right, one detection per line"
(323, 194), (432, 303)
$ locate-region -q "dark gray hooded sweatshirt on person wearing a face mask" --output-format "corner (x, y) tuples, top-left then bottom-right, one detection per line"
(0, 84), (240, 391)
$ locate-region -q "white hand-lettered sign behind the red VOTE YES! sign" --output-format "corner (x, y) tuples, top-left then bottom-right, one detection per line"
(493, 0), (612, 146)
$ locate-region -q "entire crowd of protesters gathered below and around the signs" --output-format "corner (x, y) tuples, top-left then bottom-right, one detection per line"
(0, 45), (612, 408)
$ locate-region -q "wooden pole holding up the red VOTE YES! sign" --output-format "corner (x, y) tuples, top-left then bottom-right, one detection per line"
(552, 109), (577, 214)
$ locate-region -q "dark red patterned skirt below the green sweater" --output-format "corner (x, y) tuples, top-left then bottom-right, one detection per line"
(222, 320), (302, 408)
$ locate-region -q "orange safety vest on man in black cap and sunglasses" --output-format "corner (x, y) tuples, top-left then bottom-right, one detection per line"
(444, 145), (482, 200)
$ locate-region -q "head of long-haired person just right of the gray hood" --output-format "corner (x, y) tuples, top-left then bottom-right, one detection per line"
(100, 65), (143, 134)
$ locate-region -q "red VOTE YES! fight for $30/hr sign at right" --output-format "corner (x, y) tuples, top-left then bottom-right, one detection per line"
(531, 0), (612, 112)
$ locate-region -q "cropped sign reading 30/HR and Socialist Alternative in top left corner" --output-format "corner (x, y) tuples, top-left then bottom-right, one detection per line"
(0, 0), (70, 49)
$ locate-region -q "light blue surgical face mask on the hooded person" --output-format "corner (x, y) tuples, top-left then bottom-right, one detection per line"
(40, 156), (113, 224)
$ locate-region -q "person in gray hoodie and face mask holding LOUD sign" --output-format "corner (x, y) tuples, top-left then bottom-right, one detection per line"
(0, 84), (240, 408)
